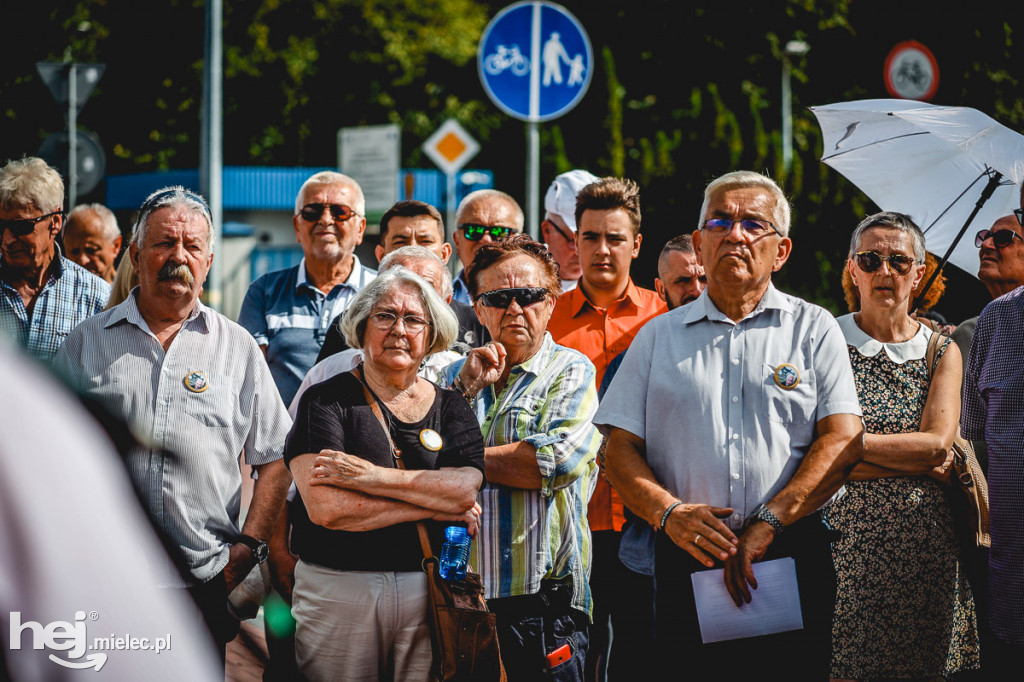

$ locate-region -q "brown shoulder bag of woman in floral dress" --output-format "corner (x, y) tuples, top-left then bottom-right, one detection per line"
(925, 334), (992, 547)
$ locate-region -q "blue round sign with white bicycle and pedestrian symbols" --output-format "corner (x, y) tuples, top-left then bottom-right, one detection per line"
(476, 2), (594, 121)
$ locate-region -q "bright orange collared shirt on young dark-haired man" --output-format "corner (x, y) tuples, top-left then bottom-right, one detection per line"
(548, 279), (669, 530)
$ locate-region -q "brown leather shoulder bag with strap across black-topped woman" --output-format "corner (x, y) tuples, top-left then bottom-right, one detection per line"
(353, 370), (508, 682)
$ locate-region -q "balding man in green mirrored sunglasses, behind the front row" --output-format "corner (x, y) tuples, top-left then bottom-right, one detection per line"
(452, 189), (525, 305)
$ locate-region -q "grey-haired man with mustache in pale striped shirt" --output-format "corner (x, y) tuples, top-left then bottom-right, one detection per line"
(54, 187), (291, 655)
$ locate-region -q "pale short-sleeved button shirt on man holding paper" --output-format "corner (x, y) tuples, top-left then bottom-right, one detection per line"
(594, 284), (861, 528)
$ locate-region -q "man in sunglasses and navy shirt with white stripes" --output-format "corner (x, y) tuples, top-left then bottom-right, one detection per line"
(239, 171), (377, 403)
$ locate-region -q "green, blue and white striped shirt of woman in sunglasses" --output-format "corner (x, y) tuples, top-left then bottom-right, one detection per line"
(438, 333), (601, 615)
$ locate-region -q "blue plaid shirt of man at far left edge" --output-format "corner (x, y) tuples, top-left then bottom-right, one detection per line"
(0, 247), (111, 363)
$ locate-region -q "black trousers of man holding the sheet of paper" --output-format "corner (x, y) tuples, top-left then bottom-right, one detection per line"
(654, 514), (836, 680)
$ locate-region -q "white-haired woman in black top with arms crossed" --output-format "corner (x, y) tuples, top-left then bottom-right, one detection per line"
(285, 266), (483, 681)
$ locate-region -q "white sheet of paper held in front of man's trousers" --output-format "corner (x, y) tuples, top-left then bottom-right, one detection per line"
(690, 557), (804, 644)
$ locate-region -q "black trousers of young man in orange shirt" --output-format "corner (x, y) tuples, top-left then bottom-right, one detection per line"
(587, 530), (654, 682)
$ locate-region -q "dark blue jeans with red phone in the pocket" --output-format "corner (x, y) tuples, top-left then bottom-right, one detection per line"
(487, 577), (590, 682)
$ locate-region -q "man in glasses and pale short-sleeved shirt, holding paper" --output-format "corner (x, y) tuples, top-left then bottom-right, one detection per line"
(594, 171), (863, 679)
